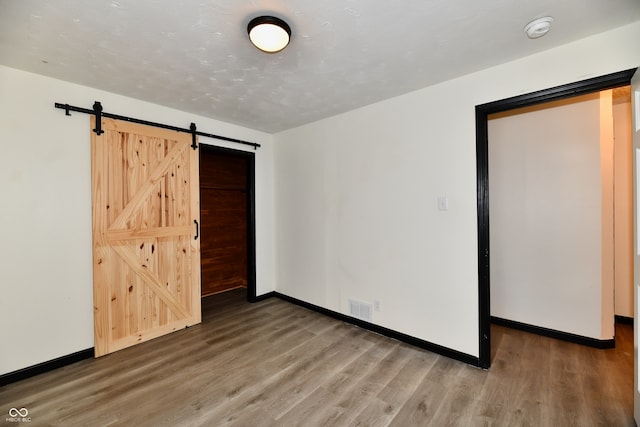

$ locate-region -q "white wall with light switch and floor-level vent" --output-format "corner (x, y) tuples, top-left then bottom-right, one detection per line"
(275, 23), (640, 356)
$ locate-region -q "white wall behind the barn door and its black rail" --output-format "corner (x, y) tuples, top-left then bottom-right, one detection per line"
(0, 66), (275, 374)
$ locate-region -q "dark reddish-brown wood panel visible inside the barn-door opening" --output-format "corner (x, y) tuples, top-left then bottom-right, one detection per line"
(200, 145), (248, 296)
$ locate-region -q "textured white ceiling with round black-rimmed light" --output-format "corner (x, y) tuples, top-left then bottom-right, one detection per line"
(0, 0), (640, 132)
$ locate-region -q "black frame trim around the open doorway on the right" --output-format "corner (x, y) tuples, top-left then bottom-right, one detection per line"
(476, 68), (636, 369)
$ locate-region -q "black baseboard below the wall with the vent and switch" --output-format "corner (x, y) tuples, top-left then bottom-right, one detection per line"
(272, 292), (480, 367)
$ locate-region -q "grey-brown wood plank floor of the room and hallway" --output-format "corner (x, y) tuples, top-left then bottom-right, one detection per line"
(0, 290), (635, 427)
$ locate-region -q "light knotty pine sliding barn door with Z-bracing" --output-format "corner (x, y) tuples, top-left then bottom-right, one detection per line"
(91, 118), (201, 357)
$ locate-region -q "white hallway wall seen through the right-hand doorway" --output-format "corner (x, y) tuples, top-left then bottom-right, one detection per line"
(489, 91), (613, 339)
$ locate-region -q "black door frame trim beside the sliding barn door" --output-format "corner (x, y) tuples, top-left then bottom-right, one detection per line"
(199, 143), (260, 302)
